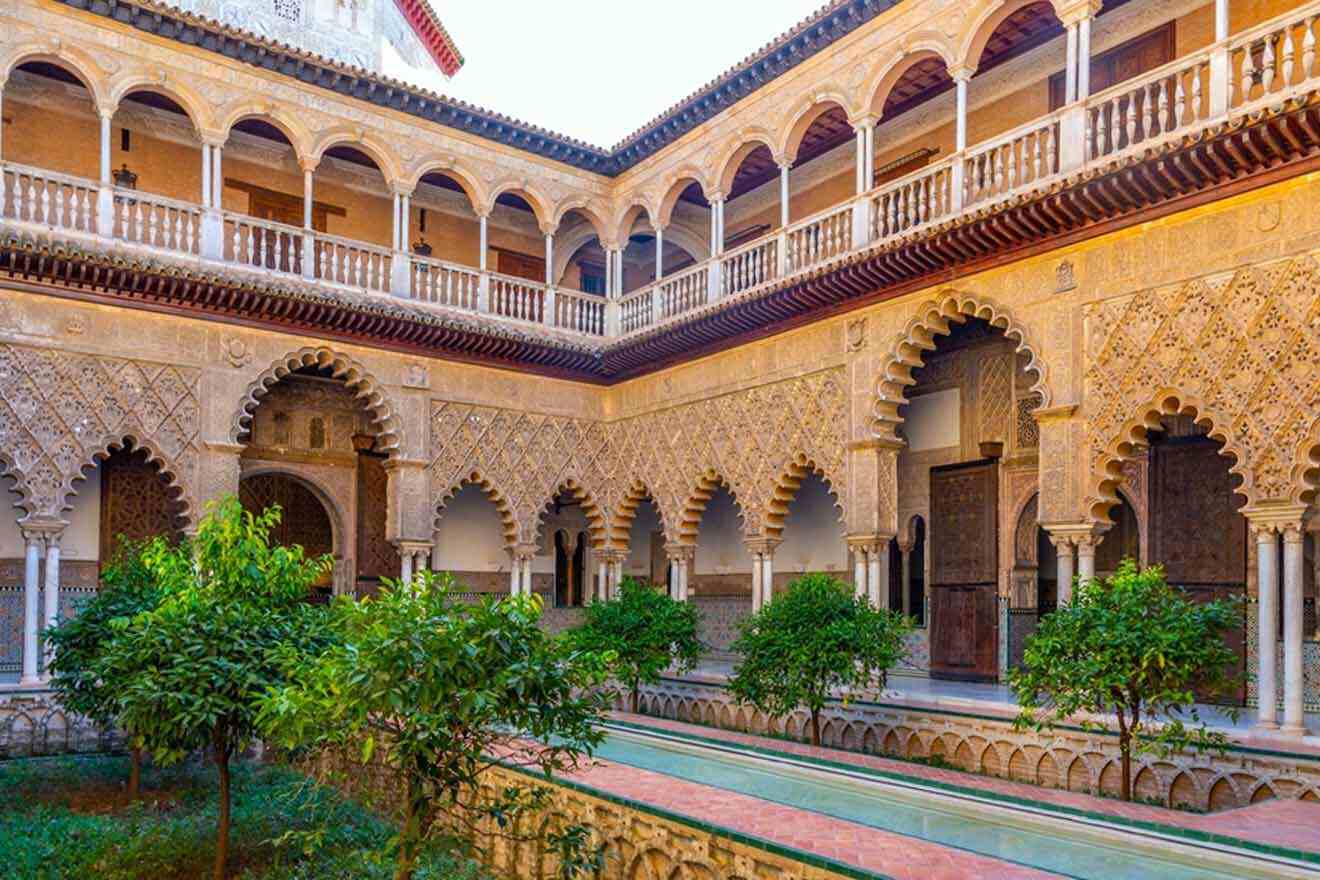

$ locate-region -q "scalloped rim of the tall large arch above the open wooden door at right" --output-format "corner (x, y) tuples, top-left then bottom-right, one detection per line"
(871, 290), (1052, 441)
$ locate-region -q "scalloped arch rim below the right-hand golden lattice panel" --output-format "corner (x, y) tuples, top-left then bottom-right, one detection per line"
(1086, 388), (1259, 524)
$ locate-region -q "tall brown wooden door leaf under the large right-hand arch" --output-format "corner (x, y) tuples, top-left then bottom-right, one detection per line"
(928, 462), (999, 681)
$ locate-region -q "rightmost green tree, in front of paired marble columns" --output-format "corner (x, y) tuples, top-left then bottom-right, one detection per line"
(1008, 559), (1242, 801)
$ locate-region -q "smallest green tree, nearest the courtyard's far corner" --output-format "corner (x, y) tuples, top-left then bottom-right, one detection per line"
(568, 578), (701, 712)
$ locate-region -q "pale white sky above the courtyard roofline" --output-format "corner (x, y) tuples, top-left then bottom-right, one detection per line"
(432, 0), (825, 148)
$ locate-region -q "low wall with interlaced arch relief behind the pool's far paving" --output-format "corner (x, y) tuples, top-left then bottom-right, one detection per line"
(640, 678), (1320, 810)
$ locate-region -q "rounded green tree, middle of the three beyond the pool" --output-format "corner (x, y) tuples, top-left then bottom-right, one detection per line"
(729, 574), (912, 745)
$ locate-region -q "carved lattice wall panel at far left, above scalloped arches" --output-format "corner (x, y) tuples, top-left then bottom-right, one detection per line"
(0, 344), (201, 517)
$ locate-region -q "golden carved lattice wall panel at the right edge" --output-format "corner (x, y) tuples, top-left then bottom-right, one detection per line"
(1084, 257), (1320, 509)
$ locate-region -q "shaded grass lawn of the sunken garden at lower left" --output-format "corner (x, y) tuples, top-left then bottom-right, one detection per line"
(0, 756), (480, 880)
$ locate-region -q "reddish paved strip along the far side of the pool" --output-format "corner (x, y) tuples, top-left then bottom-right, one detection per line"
(614, 712), (1320, 860)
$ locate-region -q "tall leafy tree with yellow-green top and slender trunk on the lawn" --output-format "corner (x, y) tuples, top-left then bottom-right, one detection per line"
(102, 497), (331, 880)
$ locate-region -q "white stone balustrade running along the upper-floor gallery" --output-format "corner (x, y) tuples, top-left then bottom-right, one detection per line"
(0, 3), (1320, 340)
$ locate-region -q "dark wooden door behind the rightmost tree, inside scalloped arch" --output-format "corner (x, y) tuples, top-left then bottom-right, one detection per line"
(1150, 437), (1246, 706)
